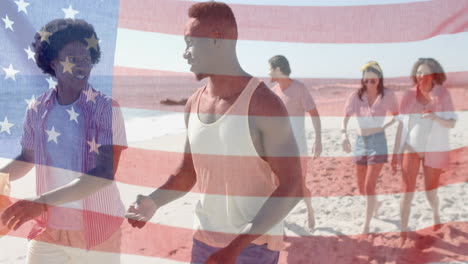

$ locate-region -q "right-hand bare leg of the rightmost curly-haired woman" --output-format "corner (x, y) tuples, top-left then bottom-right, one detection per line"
(424, 166), (442, 231)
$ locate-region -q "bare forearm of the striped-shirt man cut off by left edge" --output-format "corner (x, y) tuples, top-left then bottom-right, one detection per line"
(0, 148), (34, 181)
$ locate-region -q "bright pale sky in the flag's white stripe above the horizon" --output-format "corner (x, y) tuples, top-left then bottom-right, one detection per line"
(115, 0), (468, 78)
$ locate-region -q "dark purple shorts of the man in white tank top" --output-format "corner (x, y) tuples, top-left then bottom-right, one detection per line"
(190, 239), (279, 264)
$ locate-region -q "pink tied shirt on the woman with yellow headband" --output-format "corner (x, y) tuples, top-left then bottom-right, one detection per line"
(344, 89), (398, 128)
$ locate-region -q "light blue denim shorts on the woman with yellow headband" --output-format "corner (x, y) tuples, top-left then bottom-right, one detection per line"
(353, 132), (388, 166)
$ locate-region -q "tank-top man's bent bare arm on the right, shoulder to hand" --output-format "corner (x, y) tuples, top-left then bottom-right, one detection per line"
(229, 86), (302, 252)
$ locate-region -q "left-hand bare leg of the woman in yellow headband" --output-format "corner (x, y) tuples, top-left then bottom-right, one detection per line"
(362, 163), (384, 234)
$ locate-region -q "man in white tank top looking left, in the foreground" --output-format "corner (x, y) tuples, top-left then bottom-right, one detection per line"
(127, 2), (302, 264)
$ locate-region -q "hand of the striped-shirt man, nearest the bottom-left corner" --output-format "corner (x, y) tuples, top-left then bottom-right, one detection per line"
(1, 197), (47, 230)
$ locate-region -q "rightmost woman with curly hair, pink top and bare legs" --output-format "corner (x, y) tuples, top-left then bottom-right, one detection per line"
(392, 58), (457, 242)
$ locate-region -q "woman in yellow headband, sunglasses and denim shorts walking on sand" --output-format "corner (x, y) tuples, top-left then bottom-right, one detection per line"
(341, 61), (398, 234)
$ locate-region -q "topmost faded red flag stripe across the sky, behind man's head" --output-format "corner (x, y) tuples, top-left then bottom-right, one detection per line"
(119, 0), (468, 43)
